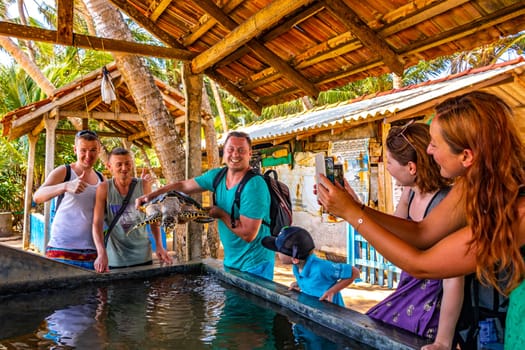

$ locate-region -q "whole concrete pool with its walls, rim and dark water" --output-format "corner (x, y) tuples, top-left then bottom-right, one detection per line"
(0, 244), (427, 350)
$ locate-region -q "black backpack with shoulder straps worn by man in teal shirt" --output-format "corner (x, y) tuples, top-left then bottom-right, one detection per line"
(213, 167), (292, 236)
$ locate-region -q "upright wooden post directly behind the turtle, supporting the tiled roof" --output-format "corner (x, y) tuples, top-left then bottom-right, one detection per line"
(182, 63), (203, 260)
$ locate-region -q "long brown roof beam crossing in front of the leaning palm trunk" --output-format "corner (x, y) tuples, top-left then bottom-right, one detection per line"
(0, 21), (195, 61)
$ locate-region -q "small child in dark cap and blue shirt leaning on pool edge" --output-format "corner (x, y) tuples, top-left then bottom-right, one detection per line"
(262, 226), (359, 307)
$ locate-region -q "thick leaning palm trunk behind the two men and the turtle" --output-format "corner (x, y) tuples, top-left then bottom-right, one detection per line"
(84, 0), (185, 182)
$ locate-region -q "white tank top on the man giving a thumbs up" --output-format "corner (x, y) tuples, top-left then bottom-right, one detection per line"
(48, 168), (100, 249)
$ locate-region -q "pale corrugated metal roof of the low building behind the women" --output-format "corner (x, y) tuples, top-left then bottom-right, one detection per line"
(228, 58), (525, 143)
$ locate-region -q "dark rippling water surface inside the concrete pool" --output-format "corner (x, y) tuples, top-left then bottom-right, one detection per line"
(0, 274), (369, 350)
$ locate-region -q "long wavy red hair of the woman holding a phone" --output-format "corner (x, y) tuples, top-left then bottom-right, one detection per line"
(436, 91), (525, 293)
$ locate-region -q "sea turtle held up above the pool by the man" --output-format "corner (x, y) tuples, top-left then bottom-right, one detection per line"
(127, 191), (214, 233)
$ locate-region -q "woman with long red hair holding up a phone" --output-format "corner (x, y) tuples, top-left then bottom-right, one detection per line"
(317, 91), (525, 349)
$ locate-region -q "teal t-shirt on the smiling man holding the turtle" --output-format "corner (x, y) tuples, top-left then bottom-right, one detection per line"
(195, 168), (275, 280)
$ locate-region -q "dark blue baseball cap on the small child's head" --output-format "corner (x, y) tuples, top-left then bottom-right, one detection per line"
(262, 226), (315, 260)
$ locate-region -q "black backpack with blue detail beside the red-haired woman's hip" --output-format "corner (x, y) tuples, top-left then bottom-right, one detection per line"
(456, 274), (509, 350)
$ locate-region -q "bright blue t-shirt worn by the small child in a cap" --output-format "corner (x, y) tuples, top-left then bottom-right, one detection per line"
(293, 254), (352, 307)
